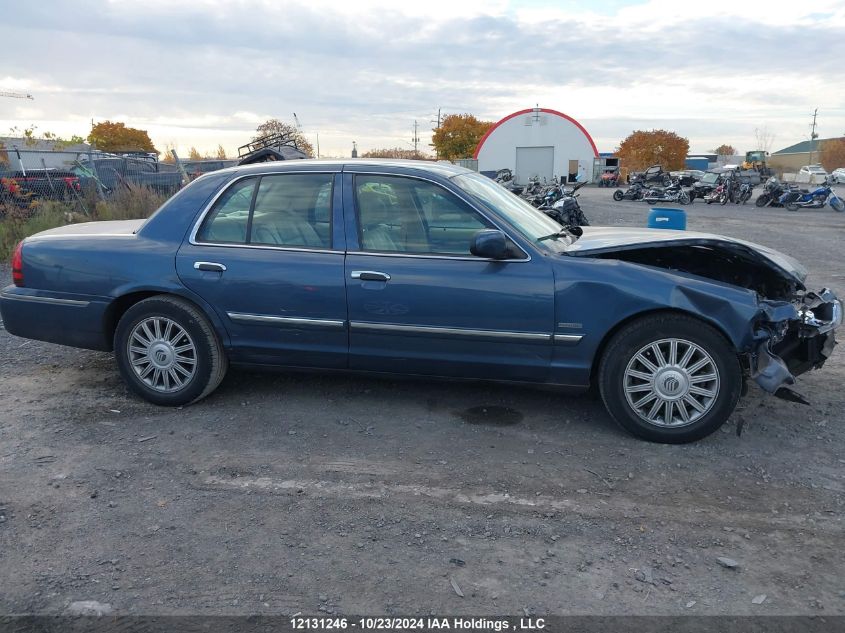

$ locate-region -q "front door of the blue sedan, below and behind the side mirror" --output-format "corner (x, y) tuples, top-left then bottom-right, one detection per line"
(344, 173), (554, 381)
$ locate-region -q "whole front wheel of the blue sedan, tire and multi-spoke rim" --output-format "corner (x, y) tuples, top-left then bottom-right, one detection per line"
(598, 314), (742, 444)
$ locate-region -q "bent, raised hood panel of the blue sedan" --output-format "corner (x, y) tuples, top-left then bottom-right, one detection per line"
(566, 226), (807, 286)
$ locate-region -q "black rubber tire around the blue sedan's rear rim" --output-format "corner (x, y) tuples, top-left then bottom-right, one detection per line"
(114, 295), (228, 407)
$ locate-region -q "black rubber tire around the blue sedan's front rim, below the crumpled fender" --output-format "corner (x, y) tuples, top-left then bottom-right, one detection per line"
(598, 313), (742, 444)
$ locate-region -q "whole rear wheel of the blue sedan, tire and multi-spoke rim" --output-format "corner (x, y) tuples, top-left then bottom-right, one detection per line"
(114, 295), (228, 407)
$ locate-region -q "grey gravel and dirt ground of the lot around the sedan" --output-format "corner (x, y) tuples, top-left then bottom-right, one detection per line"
(0, 188), (845, 615)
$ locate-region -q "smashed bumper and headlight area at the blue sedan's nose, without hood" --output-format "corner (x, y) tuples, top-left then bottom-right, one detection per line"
(748, 288), (842, 404)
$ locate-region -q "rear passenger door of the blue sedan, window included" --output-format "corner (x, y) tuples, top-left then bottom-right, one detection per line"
(176, 172), (348, 368)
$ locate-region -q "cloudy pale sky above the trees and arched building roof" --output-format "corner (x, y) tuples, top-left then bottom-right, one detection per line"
(0, 0), (845, 156)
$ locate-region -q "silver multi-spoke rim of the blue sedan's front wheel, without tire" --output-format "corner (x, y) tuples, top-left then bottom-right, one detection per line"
(622, 338), (720, 428)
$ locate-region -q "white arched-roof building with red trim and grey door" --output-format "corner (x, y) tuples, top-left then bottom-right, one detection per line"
(473, 108), (599, 184)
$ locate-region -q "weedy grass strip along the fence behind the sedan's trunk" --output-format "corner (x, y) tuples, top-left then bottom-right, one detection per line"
(0, 187), (167, 260)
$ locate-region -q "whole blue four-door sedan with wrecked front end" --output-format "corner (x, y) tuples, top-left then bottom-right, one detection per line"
(0, 160), (842, 443)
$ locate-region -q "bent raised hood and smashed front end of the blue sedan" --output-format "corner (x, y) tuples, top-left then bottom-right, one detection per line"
(568, 227), (842, 403)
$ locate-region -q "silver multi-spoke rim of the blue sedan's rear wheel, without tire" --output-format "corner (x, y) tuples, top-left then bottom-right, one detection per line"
(126, 316), (197, 393)
